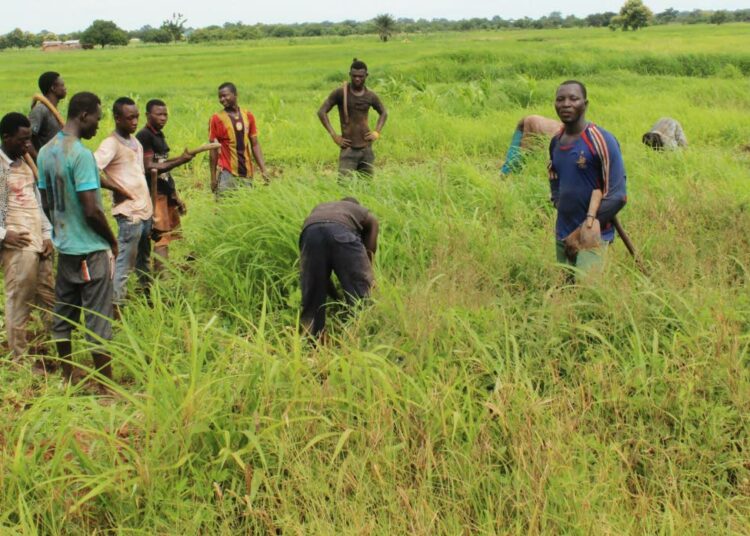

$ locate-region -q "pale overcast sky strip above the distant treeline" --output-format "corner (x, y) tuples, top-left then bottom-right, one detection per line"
(0, 0), (747, 33)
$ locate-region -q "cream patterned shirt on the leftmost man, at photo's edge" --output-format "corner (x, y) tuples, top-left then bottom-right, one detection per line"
(4, 161), (42, 253)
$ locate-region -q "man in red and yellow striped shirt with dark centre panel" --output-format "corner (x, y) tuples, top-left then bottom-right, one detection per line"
(208, 82), (266, 196)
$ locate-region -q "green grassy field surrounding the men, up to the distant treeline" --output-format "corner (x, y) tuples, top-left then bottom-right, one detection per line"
(0, 25), (750, 535)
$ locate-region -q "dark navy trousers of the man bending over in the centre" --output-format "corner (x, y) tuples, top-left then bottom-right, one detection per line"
(299, 223), (373, 336)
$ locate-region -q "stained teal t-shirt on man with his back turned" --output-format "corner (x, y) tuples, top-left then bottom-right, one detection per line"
(37, 132), (109, 255)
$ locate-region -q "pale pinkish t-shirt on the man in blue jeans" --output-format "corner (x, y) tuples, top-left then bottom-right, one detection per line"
(94, 132), (154, 220)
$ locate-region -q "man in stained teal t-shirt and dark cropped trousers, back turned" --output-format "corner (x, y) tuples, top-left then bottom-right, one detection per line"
(37, 92), (117, 390)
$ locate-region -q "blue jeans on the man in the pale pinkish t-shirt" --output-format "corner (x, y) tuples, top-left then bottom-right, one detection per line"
(114, 215), (152, 305)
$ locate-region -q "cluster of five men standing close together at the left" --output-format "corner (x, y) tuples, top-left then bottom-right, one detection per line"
(0, 72), (197, 386)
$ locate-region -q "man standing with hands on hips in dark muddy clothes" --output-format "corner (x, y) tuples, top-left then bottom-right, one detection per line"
(318, 58), (388, 176)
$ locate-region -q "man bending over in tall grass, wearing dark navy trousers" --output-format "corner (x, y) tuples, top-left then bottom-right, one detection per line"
(299, 197), (378, 337)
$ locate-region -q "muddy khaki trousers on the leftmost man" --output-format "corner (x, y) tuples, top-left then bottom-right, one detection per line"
(2, 248), (55, 358)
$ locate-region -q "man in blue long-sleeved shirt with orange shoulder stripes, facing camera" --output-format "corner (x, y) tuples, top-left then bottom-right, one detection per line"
(548, 80), (627, 274)
